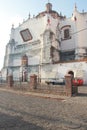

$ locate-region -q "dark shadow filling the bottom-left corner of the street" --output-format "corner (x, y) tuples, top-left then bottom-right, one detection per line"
(0, 113), (44, 130)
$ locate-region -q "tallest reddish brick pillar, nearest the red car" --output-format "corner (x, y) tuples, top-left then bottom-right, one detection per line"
(65, 74), (72, 97)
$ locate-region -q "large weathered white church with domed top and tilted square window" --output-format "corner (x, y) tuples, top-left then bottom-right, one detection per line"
(2, 2), (87, 84)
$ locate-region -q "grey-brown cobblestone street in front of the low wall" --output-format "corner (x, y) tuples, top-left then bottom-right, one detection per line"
(0, 88), (87, 130)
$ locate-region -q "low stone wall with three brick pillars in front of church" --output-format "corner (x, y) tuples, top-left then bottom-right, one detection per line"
(0, 75), (78, 97)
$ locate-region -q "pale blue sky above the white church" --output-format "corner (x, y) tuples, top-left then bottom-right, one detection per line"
(0, 0), (87, 69)
